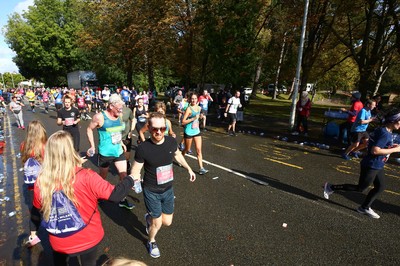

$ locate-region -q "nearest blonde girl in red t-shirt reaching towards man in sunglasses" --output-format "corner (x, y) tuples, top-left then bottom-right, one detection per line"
(31, 130), (134, 265)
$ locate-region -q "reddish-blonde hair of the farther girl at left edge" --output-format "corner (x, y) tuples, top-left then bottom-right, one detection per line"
(21, 120), (47, 163)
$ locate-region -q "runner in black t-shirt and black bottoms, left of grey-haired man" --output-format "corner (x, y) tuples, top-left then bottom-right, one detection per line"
(57, 95), (81, 151)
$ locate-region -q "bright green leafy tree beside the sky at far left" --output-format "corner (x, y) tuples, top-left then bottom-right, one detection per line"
(5, 0), (88, 85)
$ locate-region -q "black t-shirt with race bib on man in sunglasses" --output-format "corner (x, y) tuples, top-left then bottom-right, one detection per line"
(135, 136), (178, 193)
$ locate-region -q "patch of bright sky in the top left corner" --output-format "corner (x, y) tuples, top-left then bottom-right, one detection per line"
(0, 0), (34, 73)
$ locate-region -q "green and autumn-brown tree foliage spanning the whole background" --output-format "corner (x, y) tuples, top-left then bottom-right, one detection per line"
(5, 0), (400, 95)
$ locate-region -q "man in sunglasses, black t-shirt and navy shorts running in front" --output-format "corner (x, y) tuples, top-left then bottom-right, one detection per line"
(131, 113), (196, 258)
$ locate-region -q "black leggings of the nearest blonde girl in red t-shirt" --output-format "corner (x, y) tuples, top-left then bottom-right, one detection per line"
(53, 244), (99, 266)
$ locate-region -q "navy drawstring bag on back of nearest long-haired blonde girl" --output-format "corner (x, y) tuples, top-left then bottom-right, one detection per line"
(41, 169), (96, 237)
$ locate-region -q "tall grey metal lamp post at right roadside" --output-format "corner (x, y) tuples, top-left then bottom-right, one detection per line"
(289, 0), (309, 130)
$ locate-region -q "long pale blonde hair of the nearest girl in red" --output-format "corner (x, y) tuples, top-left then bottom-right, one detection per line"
(37, 130), (82, 221)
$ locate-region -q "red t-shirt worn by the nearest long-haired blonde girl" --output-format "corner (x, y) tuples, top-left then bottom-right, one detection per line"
(33, 168), (114, 254)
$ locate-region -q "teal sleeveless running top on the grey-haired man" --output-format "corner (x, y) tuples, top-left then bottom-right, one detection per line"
(97, 112), (125, 157)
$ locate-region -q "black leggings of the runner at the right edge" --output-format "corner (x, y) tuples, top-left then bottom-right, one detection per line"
(331, 167), (386, 209)
